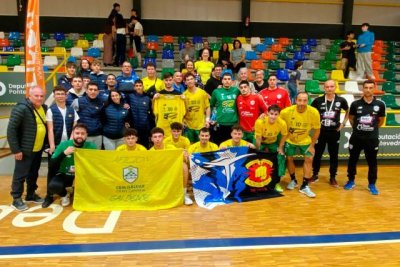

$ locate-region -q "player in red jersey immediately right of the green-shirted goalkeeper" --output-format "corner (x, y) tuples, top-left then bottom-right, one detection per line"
(236, 80), (267, 142)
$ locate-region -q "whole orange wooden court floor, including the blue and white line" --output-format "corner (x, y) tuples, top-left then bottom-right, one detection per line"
(0, 165), (400, 266)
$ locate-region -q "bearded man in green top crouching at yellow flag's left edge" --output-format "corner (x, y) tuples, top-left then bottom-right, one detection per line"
(42, 123), (97, 208)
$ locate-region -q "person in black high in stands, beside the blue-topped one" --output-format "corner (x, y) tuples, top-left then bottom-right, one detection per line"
(340, 31), (357, 79)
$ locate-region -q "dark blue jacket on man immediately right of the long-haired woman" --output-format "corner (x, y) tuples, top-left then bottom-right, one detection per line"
(126, 92), (154, 130)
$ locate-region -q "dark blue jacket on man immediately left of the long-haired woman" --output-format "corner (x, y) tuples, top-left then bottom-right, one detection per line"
(77, 96), (104, 136)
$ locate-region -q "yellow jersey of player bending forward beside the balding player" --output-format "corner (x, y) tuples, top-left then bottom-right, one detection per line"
(254, 116), (288, 144)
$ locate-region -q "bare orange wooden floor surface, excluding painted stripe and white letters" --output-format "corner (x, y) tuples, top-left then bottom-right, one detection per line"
(0, 166), (400, 266)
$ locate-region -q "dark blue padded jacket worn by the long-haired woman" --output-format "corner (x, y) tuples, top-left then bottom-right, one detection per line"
(102, 103), (129, 139)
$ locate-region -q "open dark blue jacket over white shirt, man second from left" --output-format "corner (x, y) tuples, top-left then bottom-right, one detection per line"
(50, 104), (75, 146)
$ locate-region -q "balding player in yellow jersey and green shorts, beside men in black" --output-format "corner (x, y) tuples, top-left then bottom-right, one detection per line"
(281, 92), (321, 198)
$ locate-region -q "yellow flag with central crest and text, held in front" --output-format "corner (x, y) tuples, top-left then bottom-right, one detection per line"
(73, 149), (183, 211)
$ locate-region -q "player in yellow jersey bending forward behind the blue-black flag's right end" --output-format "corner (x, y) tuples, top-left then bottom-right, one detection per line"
(254, 105), (288, 193)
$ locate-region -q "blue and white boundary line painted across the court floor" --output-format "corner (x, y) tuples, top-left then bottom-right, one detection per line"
(0, 232), (400, 259)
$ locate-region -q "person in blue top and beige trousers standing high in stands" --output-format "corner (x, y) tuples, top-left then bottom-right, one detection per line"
(357, 23), (375, 80)
